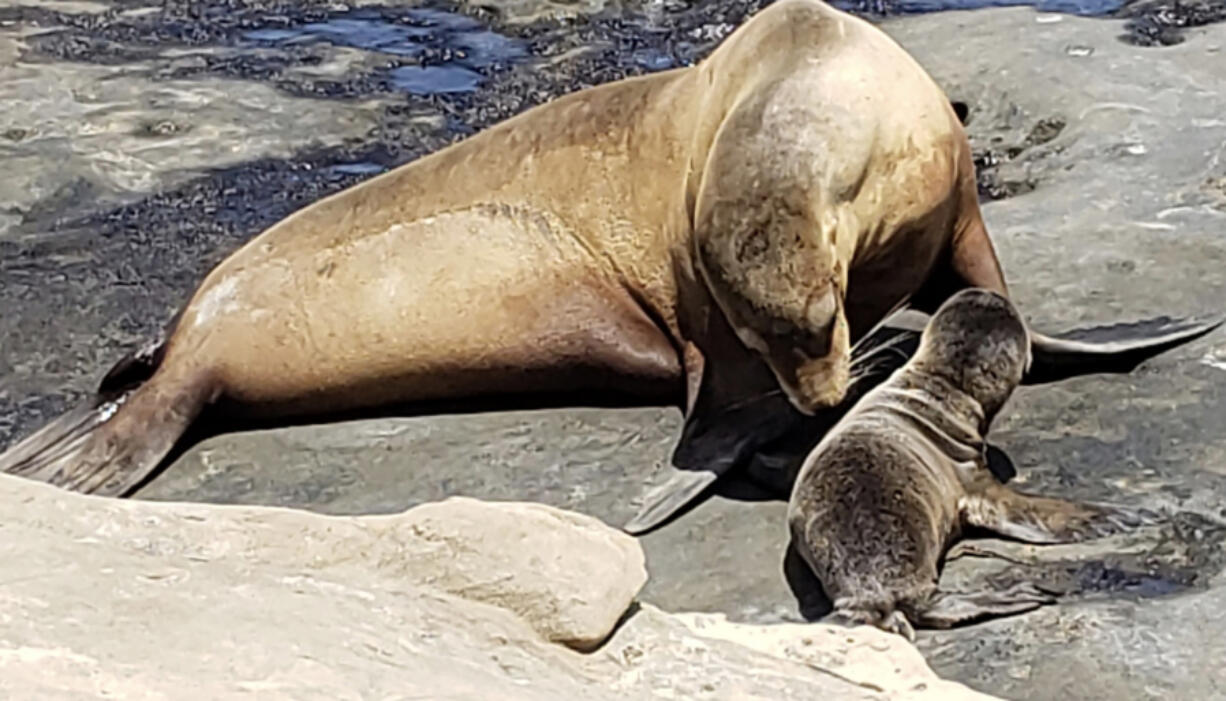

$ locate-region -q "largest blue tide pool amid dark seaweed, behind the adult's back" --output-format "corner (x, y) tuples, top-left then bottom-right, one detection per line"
(242, 7), (527, 96)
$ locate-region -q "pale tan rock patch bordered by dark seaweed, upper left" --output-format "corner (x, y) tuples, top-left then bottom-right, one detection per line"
(0, 31), (376, 241)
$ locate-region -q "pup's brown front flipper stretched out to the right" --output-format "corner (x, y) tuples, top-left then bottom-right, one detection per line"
(960, 484), (1157, 544)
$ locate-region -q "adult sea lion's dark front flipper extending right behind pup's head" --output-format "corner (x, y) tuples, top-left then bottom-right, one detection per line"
(1022, 317), (1226, 385)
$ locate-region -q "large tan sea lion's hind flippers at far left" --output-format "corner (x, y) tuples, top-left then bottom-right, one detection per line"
(0, 340), (208, 496)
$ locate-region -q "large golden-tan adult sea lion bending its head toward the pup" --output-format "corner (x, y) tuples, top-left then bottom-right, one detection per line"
(0, 0), (1204, 514)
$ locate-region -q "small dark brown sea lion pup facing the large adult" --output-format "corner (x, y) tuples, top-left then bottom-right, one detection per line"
(787, 289), (1148, 638)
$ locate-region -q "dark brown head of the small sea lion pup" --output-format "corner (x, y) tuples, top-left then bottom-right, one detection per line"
(915, 288), (1030, 417)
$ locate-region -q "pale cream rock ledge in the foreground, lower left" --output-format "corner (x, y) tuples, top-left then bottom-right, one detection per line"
(0, 476), (989, 700)
